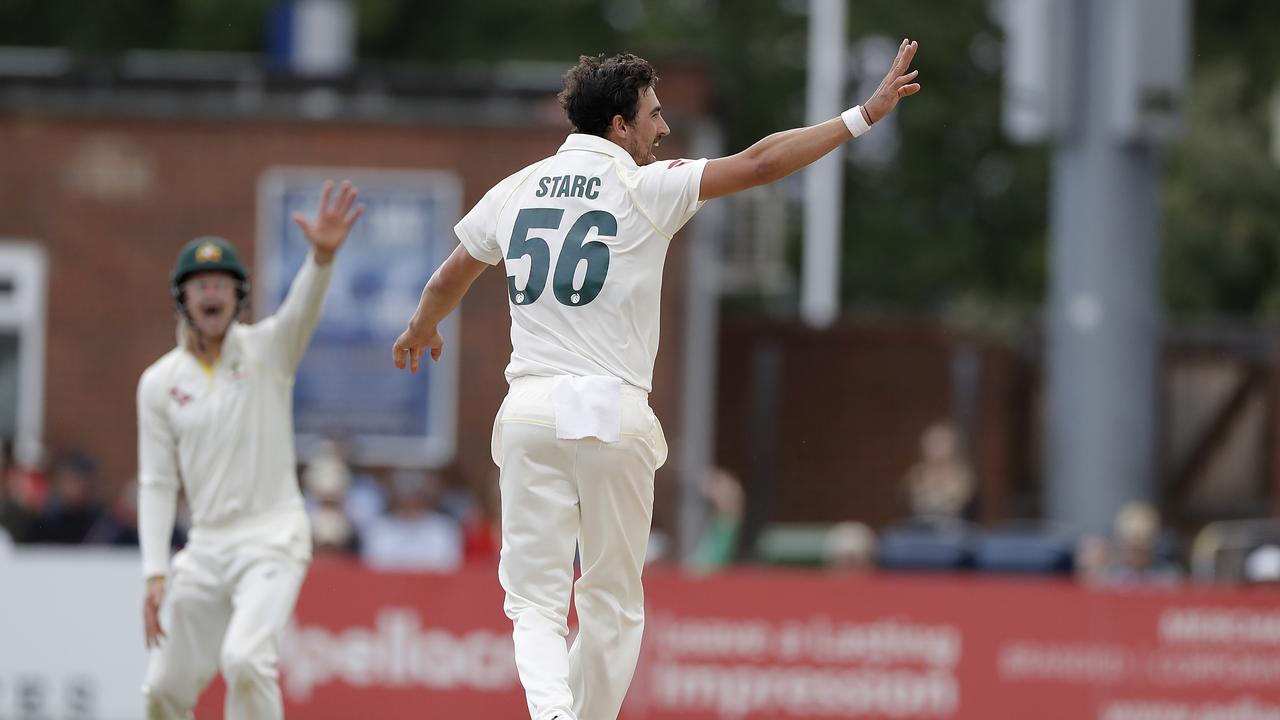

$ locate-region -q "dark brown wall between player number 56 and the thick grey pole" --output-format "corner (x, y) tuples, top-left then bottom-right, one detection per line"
(716, 320), (1018, 525)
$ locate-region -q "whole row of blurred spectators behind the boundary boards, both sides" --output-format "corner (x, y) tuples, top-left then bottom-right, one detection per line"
(0, 421), (1280, 587)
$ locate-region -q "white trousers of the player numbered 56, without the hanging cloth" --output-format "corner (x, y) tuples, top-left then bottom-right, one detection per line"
(493, 377), (667, 720)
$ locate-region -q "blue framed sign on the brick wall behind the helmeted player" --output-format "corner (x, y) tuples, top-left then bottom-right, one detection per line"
(253, 168), (461, 465)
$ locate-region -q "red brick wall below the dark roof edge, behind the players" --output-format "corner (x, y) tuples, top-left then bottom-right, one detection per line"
(0, 114), (701, 504)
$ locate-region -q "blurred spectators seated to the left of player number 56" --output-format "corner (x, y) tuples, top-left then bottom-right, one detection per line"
(0, 435), (499, 573)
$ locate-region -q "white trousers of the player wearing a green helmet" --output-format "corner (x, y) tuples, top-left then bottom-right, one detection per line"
(142, 510), (311, 720)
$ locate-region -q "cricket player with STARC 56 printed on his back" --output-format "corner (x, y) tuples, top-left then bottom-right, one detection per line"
(392, 40), (920, 720)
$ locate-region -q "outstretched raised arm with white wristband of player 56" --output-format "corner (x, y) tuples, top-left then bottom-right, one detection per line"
(698, 40), (920, 200)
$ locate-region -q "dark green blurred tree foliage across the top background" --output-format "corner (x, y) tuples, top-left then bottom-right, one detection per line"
(0, 0), (1280, 318)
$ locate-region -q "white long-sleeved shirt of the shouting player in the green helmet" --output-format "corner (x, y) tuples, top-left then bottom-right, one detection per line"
(137, 254), (333, 578)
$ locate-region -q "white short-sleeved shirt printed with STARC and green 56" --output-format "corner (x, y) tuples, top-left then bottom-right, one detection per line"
(454, 133), (707, 392)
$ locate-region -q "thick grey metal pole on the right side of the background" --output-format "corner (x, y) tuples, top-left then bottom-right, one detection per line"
(1046, 0), (1182, 532)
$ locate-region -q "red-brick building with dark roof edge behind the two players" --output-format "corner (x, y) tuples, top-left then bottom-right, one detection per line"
(0, 53), (707, 515)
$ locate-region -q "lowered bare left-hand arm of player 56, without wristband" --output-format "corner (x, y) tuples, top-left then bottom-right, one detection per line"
(392, 243), (489, 373)
